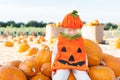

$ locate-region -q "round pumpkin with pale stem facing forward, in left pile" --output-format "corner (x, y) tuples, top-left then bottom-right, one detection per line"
(19, 59), (39, 77)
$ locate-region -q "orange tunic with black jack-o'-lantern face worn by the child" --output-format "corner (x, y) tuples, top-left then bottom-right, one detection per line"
(52, 35), (88, 70)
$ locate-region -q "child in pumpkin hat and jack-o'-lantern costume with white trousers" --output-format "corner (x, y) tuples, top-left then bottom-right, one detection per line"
(52, 10), (90, 80)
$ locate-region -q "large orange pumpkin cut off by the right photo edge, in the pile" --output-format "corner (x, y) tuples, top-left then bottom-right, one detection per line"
(103, 54), (120, 77)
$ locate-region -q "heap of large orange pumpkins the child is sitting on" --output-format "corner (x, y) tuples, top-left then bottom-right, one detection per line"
(0, 35), (120, 80)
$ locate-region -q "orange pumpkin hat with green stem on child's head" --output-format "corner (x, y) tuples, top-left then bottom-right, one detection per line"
(62, 10), (83, 29)
